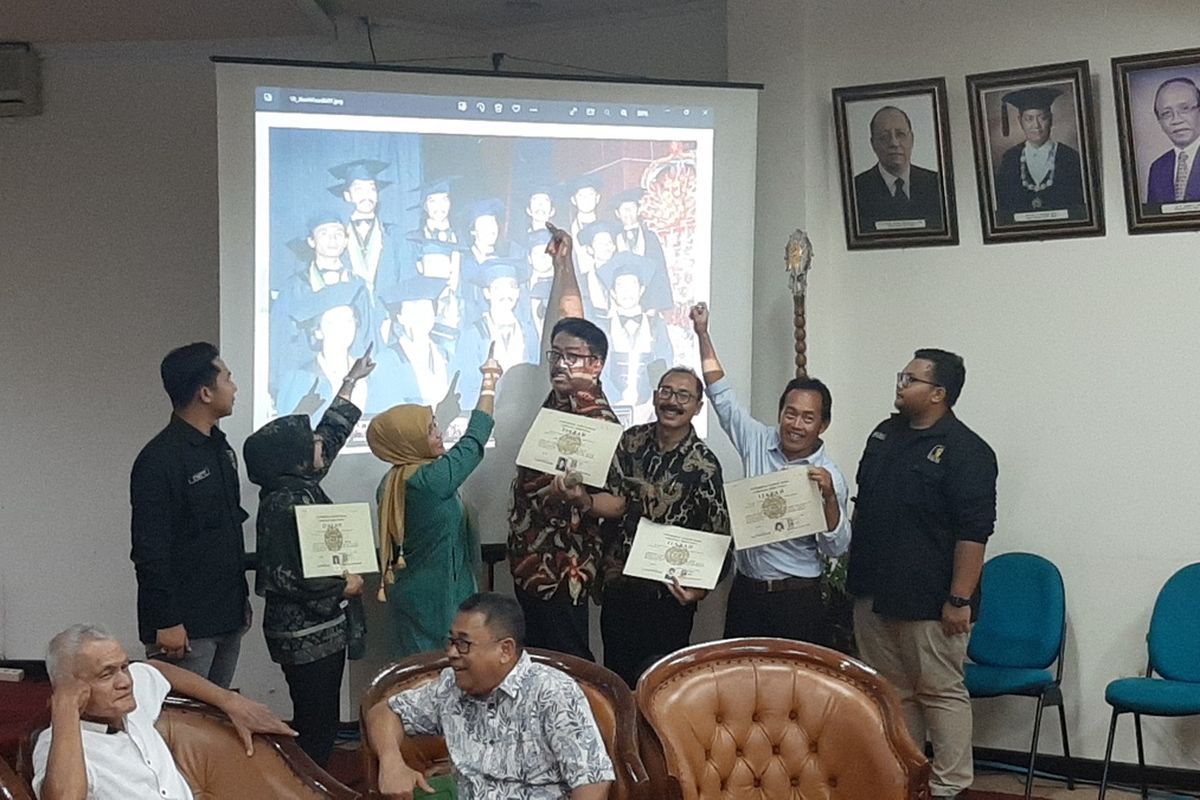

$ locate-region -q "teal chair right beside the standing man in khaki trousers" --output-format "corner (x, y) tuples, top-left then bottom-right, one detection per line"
(966, 553), (1075, 800)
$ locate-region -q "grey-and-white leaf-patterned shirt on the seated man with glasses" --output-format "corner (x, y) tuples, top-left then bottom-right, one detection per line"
(388, 652), (614, 800)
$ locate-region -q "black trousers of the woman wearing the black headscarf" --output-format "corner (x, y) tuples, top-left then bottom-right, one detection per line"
(281, 648), (346, 768)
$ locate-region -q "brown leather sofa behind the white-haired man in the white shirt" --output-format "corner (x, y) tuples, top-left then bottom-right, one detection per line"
(17, 697), (360, 800)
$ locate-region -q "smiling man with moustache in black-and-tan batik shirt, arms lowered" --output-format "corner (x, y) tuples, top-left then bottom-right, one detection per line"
(600, 367), (730, 687)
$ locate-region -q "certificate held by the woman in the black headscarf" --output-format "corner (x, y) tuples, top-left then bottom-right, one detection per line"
(296, 503), (379, 578)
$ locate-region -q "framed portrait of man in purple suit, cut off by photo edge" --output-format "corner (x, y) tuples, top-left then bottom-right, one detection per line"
(1112, 49), (1200, 234)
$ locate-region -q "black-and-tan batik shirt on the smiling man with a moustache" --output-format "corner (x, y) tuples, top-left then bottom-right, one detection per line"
(604, 422), (730, 577)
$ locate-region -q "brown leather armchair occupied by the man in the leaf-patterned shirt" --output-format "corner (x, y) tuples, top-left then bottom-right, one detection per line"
(359, 648), (658, 800)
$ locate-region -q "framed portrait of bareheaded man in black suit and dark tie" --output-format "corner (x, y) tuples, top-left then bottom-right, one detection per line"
(833, 78), (959, 249)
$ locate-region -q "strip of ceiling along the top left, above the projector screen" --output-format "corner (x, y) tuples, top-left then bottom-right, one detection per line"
(7, 0), (696, 43)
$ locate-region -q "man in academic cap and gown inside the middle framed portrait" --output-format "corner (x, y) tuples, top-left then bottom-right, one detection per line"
(996, 86), (1086, 223)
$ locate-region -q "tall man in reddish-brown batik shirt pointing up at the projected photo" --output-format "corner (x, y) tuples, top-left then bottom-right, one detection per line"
(508, 223), (624, 661)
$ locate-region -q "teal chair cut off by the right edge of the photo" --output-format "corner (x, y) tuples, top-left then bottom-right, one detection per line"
(1100, 564), (1200, 800)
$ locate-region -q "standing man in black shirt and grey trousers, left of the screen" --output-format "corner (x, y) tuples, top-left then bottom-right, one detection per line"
(130, 342), (250, 688)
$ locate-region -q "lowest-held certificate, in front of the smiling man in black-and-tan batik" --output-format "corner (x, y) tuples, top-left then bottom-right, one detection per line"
(623, 519), (730, 589)
